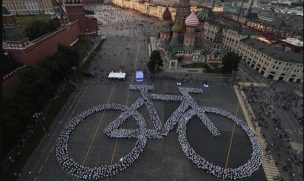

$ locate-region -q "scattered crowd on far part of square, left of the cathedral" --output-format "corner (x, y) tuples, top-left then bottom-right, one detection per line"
(84, 5), (161, 80)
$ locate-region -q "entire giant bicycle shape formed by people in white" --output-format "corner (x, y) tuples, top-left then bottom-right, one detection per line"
(56, 85), (263, 180)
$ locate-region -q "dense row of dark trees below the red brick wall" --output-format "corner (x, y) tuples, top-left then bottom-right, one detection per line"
(2, 45), (80, 153)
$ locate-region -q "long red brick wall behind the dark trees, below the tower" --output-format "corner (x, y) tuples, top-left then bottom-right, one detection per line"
(6, 21), (80, 67)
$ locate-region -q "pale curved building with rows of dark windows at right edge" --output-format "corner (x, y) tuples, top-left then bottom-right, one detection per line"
(238, 38), (303, 83)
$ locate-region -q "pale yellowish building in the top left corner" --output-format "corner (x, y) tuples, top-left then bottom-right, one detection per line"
(3, 0), (54, 15)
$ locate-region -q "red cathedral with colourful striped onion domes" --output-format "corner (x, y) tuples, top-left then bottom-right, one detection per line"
(157, 0), (221, 68)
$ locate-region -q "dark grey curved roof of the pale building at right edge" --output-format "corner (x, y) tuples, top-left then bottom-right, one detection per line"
(241, 38), (303, 63)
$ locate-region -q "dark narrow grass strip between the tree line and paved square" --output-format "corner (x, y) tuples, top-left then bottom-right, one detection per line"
(1, 84), (75, 180)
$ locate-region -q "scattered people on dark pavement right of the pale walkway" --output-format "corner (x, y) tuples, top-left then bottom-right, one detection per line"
(243, 83), (303, 179)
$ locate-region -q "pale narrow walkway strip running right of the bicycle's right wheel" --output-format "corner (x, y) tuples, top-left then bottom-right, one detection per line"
(234, 85), (280, 181)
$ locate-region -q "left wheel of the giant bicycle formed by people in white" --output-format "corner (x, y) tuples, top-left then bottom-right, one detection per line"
(56, 104), (147, 180)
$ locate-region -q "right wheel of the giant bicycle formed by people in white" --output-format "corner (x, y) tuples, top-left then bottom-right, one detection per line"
(177, 107), (263, 180)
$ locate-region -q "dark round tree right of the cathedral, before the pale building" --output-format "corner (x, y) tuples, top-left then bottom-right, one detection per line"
(222, 52), (242, 74)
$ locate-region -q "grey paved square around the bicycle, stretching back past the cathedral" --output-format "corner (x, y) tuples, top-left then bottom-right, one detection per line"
(19, 6), (266, 181)
